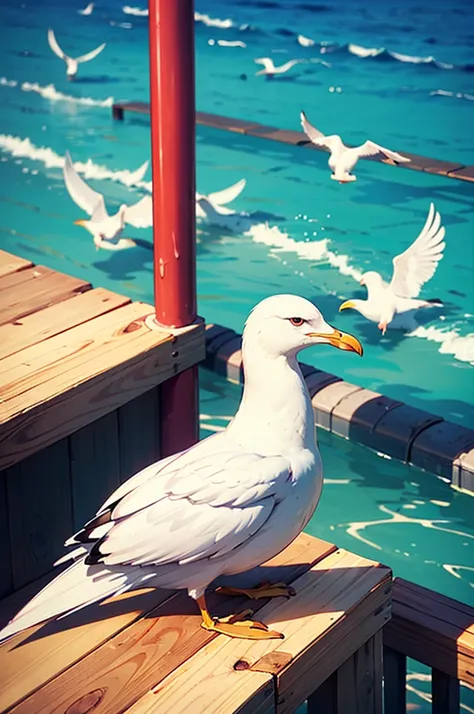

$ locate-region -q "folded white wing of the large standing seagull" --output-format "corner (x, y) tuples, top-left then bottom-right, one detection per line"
(70, 450), (292, 566)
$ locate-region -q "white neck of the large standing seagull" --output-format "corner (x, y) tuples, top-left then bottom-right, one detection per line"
(229, 337), (316, 453)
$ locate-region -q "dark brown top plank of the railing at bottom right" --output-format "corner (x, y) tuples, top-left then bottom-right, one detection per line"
(384, 579), (474, 686)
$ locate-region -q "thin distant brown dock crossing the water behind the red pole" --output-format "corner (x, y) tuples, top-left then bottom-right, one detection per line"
(112, 102), (474, 181)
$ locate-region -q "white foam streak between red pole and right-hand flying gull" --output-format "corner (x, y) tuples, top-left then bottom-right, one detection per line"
(247, 223), (362, 281)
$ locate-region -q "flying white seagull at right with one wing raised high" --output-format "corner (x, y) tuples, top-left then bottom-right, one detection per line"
(339, 203), (446, 335)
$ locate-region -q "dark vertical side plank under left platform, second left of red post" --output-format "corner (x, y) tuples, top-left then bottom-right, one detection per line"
(69, 411), (120, 532)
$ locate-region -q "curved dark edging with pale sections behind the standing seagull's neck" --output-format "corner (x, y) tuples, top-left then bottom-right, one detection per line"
(204, 325), (474, 493)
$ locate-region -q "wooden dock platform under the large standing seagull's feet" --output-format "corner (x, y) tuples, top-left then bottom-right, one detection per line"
(0, 534), (391, 714)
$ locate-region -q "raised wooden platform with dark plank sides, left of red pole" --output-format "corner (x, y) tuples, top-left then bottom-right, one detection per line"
(0, 251), (205, 597)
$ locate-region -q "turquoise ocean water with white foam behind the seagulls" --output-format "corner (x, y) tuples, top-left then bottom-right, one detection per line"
(0, 0), (474, 711)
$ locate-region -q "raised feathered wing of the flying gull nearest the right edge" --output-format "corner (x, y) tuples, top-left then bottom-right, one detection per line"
(390, 203), (446, 298)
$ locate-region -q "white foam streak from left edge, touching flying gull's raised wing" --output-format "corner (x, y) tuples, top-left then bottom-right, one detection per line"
(0, 134), (148, 188)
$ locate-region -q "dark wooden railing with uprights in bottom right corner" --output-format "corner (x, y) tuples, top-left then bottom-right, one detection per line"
(383, 578), (474, 714)
